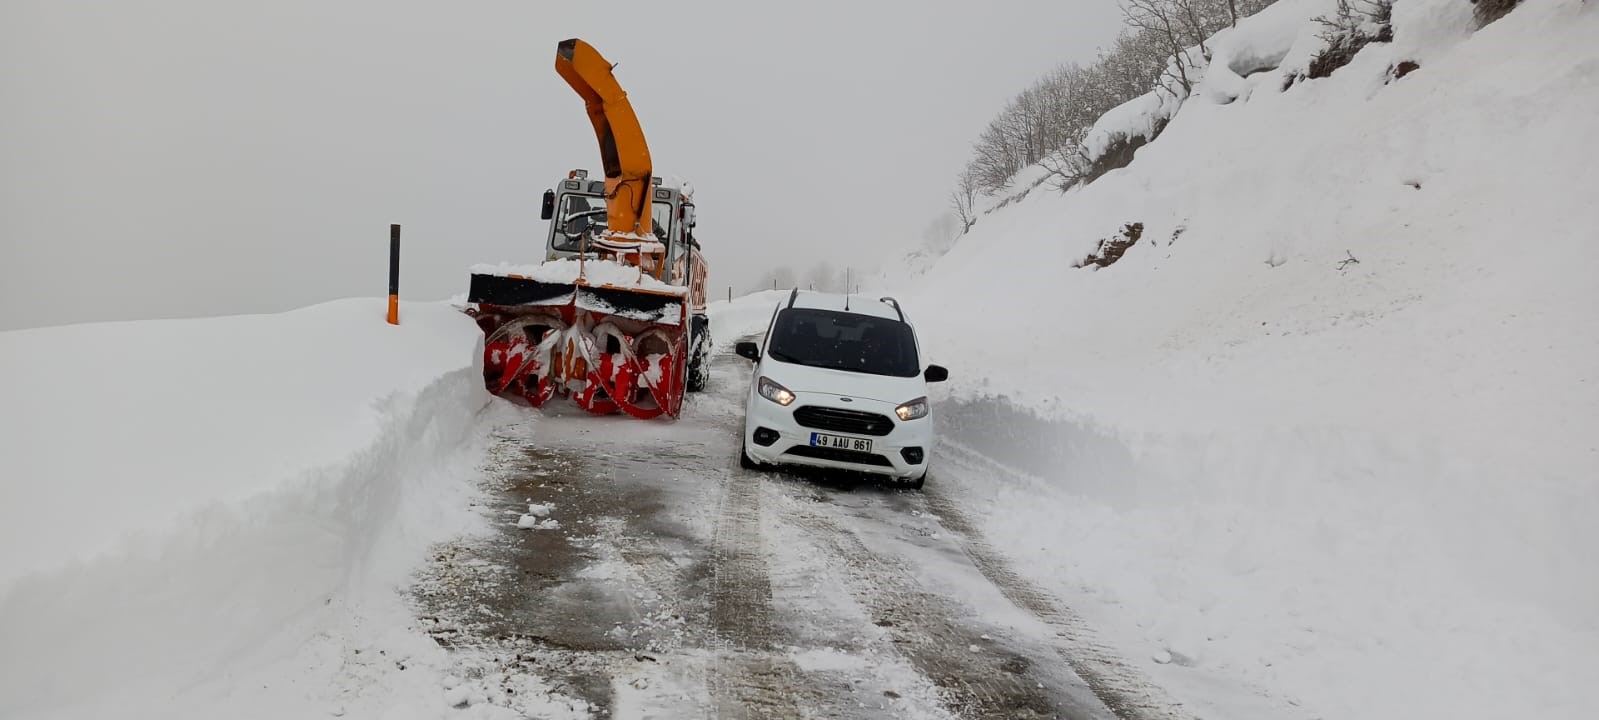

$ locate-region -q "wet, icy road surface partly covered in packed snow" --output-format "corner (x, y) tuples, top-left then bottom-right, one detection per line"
(414, 354), (1180, 718)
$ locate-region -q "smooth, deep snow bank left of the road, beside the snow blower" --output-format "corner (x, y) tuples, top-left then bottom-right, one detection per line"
(0, 299), (502, 717)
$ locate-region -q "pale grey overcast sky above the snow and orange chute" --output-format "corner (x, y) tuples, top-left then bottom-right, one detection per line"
(0, 0), (1118, 330)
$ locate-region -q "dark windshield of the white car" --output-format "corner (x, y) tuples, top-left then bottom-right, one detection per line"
(766, 307), (921, 378)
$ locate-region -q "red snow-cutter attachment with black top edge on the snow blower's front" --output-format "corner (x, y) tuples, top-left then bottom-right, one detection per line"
(467, 267), (689, 419)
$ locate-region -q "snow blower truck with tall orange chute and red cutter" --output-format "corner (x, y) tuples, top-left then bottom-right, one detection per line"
(465, 40), (710, 419)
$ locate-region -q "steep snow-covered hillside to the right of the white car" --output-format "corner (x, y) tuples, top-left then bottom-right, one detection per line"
(910, 0), (1599, 718)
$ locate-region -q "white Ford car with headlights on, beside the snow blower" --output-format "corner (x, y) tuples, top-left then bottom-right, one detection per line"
(737, 290), (950, 488)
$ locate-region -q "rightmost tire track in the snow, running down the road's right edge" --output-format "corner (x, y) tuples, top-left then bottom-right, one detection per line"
(923, 442), (1190, 720)
